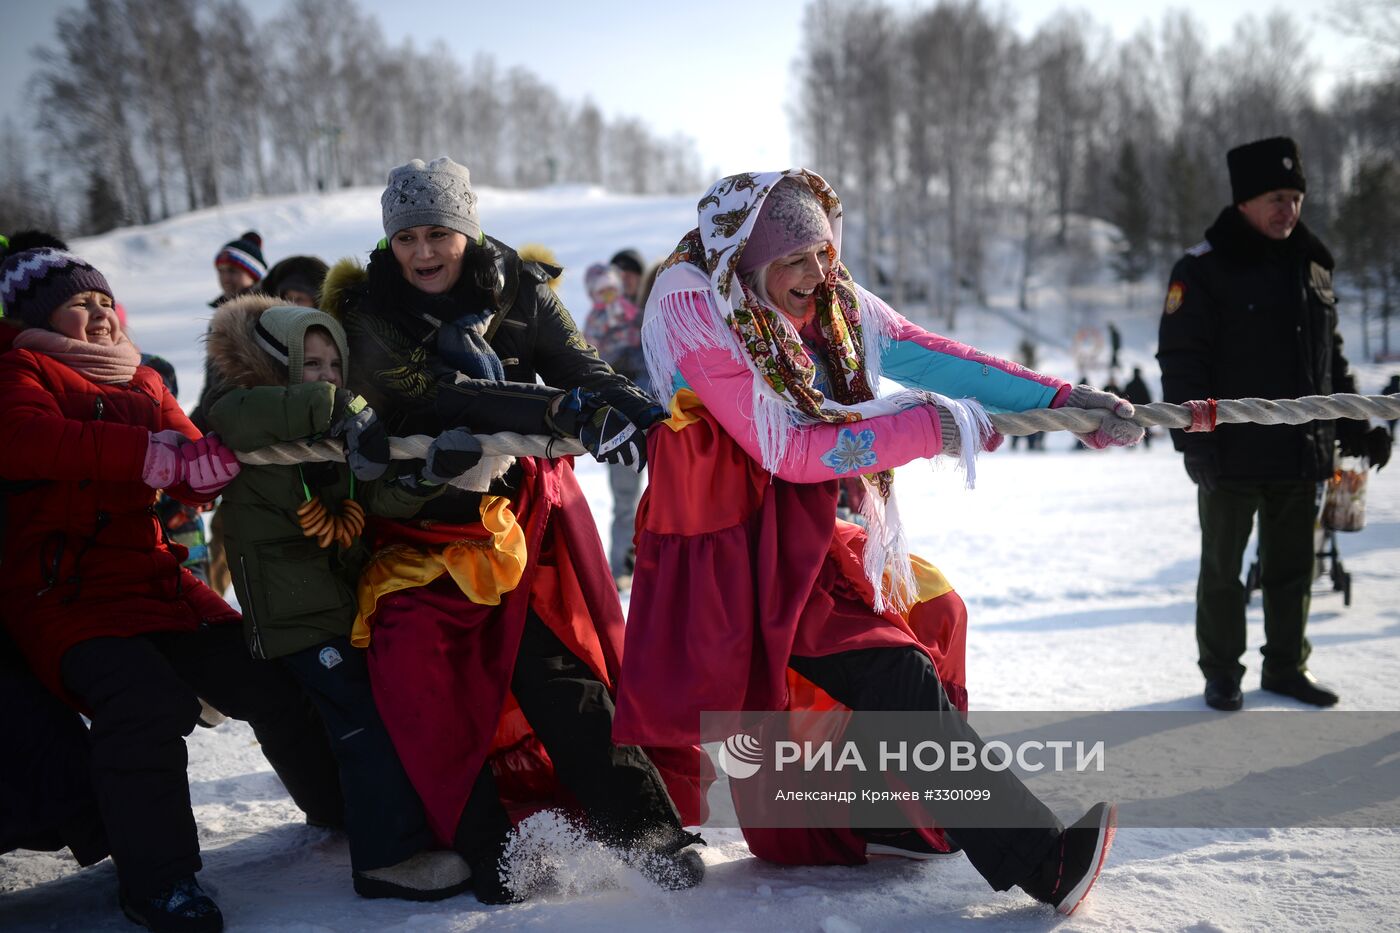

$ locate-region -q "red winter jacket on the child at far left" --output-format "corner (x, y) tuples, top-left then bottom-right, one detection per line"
(0, 350), (239, 700)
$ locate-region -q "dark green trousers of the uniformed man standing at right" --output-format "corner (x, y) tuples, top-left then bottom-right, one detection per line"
(1196, 481), (1319, 679)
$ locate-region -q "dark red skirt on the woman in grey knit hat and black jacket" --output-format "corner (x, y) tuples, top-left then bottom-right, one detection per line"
(368, 459), (714, 845)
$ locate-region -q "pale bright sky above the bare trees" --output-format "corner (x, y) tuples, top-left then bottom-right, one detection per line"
(0, 0), (1365, 174)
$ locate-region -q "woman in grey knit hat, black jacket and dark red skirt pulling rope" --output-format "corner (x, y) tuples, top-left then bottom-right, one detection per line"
(322, 158), (704, 901)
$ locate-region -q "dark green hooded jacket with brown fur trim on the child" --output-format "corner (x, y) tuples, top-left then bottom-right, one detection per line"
(209, 294), (424, 657)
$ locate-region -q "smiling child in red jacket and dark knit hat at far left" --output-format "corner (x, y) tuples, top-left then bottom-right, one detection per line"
(0, 240), (343, 932)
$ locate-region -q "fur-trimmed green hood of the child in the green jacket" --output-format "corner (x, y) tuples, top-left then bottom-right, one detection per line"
(207, 293), (350, 388)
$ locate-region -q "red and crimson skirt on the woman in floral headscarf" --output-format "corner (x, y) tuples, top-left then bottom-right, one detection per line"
(613, 399), (967, 864)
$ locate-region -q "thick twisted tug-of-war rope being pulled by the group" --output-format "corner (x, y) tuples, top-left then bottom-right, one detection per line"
(238, 394), (1400, 492)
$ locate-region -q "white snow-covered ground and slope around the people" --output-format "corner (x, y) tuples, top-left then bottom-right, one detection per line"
(0, 189), (1400, 933)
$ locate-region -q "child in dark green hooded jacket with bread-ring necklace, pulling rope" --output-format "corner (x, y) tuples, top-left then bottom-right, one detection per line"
(200, 296), (480, 901)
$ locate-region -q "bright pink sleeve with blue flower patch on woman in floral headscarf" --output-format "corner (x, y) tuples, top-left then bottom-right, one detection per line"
(679, 341), (942, 483)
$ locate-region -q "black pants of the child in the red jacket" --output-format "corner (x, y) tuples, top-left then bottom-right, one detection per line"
(60, 625), (344, 898)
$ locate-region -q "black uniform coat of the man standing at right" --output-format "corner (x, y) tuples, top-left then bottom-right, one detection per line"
(1156, 206), (1364, 481)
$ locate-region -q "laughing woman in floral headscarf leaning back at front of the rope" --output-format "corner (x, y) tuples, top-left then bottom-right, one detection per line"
(613, 170), (1142, 913)
